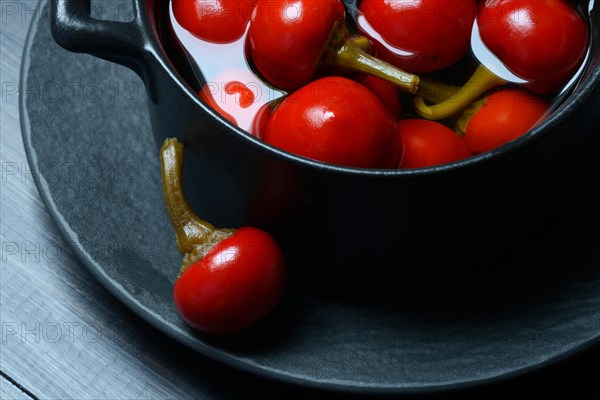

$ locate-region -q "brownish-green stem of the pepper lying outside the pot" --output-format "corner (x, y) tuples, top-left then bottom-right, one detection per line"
(160, 138), (216, 254)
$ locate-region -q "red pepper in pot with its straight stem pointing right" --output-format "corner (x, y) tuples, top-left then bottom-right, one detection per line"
(248, 0), (419, 93)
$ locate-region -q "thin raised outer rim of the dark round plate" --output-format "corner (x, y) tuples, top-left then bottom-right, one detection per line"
(19, 0), (600, 395)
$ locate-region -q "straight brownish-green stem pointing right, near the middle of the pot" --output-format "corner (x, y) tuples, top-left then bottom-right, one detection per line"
(330, 39), (419, 94)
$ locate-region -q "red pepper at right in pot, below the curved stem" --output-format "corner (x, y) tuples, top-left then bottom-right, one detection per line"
(464, 89), (548, 154)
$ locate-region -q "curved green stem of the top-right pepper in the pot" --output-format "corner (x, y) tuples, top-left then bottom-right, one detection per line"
(414, 65), (507, 120)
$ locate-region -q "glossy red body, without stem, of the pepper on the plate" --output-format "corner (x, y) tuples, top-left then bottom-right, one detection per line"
(174, 228), (285, 334)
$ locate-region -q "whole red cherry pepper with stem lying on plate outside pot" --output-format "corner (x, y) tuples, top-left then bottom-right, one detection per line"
(161, 139), (285, 334)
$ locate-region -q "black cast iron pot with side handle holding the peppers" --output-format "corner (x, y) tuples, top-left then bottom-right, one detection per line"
(52, 0), (600, 287)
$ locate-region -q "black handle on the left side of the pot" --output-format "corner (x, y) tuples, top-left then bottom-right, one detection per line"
(50, 0), (147, 63)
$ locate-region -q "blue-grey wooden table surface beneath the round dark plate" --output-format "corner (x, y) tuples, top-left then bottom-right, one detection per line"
(0, 0), (600, 399)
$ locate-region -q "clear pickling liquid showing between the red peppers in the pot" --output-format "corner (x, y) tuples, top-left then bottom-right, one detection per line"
(169, 0), (598, 141)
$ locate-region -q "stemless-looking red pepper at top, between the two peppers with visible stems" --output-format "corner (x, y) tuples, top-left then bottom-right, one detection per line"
(358, 0), (477, 73)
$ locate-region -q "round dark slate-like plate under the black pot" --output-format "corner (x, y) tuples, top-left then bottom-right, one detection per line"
(21, 3), (600, 393)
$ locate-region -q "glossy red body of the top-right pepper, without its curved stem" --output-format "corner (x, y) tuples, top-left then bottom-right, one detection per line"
(478, 0), (588, 93)
